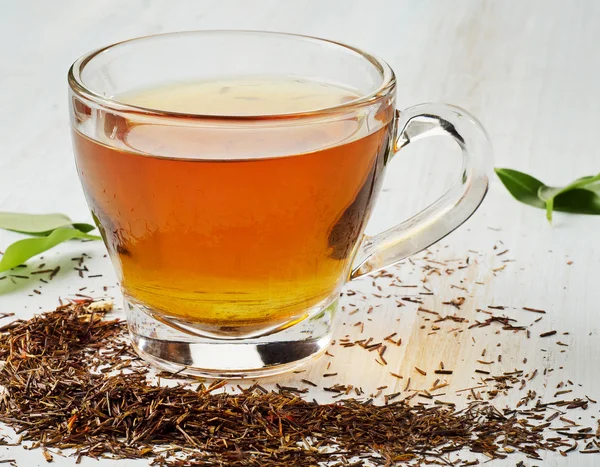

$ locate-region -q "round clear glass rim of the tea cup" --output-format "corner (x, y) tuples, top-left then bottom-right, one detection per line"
(67, 29), (396, 123)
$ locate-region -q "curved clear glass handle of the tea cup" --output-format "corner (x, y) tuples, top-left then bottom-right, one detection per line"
(349, 104), (493, 280)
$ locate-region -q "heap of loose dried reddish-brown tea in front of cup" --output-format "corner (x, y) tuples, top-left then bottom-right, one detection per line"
(0, 300), (597, 467)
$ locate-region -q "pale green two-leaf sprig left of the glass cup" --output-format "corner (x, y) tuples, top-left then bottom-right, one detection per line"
(0, 212), (101, 272)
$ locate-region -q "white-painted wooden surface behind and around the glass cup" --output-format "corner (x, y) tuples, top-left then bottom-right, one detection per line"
(0, 0), (600, 467)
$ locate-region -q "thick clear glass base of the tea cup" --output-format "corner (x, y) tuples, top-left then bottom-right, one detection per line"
(125, 294), (339, 378)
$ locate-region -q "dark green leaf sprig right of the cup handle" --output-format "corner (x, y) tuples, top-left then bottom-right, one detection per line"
(495, 169), (600, 221)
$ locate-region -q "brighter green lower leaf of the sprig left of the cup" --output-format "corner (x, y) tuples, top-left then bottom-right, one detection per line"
(0, 227), (100, 272)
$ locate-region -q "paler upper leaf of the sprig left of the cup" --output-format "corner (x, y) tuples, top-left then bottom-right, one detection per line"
(0, 212), (96, 235)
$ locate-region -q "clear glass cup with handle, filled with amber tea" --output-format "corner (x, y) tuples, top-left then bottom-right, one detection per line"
(68, 31), (492, 377)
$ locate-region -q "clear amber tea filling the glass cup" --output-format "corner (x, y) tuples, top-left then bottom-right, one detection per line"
(74, 78), (392, 328)
